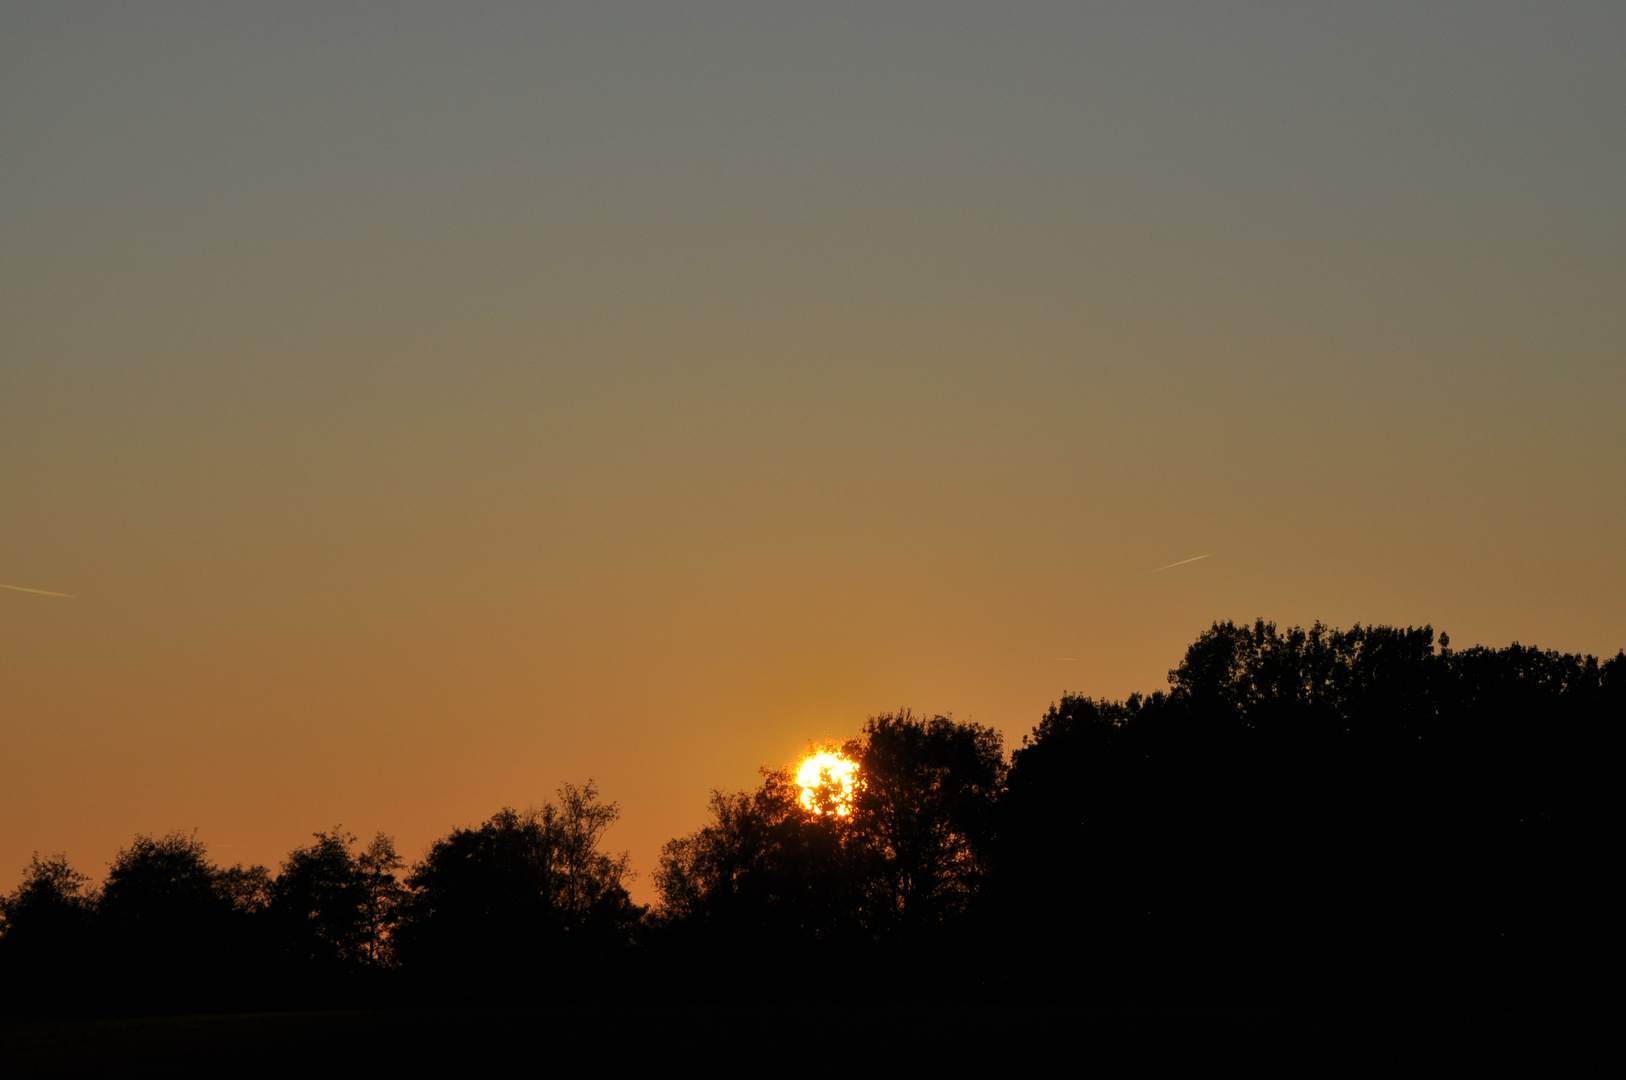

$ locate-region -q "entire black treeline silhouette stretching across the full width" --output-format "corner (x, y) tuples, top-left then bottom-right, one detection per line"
(0, 621), (1626, 1012)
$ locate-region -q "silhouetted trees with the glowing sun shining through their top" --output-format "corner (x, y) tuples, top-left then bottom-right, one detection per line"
(655, 711), (1005, 948)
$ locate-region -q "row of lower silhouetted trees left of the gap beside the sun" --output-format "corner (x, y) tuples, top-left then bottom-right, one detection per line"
(0, 782), (647, 1012)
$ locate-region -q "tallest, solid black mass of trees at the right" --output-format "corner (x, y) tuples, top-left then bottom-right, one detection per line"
(990, 621), (1626, 994)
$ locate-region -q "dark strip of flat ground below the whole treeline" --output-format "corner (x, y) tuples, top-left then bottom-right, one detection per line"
(0, 994), (1626, 1080)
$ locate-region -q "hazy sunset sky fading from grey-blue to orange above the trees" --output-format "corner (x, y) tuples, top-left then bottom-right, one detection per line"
(0, 2), (1626, 901)
